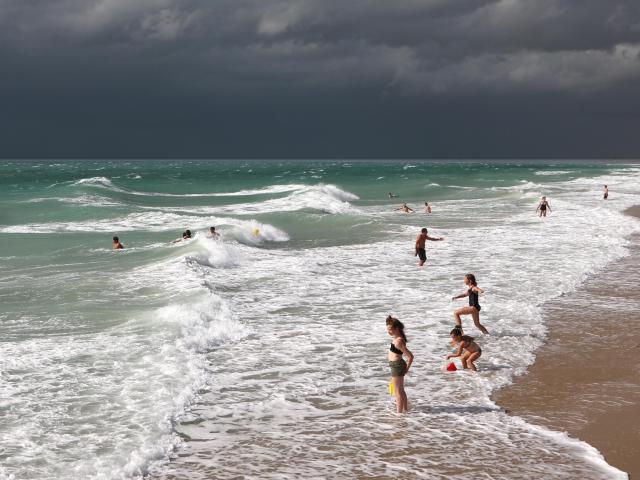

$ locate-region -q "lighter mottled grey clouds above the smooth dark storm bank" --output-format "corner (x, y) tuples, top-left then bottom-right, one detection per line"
(0, 0), (640, 93)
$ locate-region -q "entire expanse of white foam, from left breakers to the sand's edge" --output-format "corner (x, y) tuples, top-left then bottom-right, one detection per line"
(0, 166), (639, 479)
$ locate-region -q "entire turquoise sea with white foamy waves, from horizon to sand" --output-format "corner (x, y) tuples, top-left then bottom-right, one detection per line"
(0, 161), (640, 479)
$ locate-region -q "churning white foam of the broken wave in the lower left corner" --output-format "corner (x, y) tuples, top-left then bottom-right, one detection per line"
(0, 242), (250, 480)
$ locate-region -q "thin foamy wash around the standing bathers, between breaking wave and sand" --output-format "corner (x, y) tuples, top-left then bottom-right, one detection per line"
(146, 170), (638, 479)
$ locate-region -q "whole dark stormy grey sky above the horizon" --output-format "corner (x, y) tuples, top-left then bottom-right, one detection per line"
(0, 0), (640, 159)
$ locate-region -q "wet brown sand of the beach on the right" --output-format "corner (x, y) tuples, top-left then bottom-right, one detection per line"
(493, 206), (640, 480)
